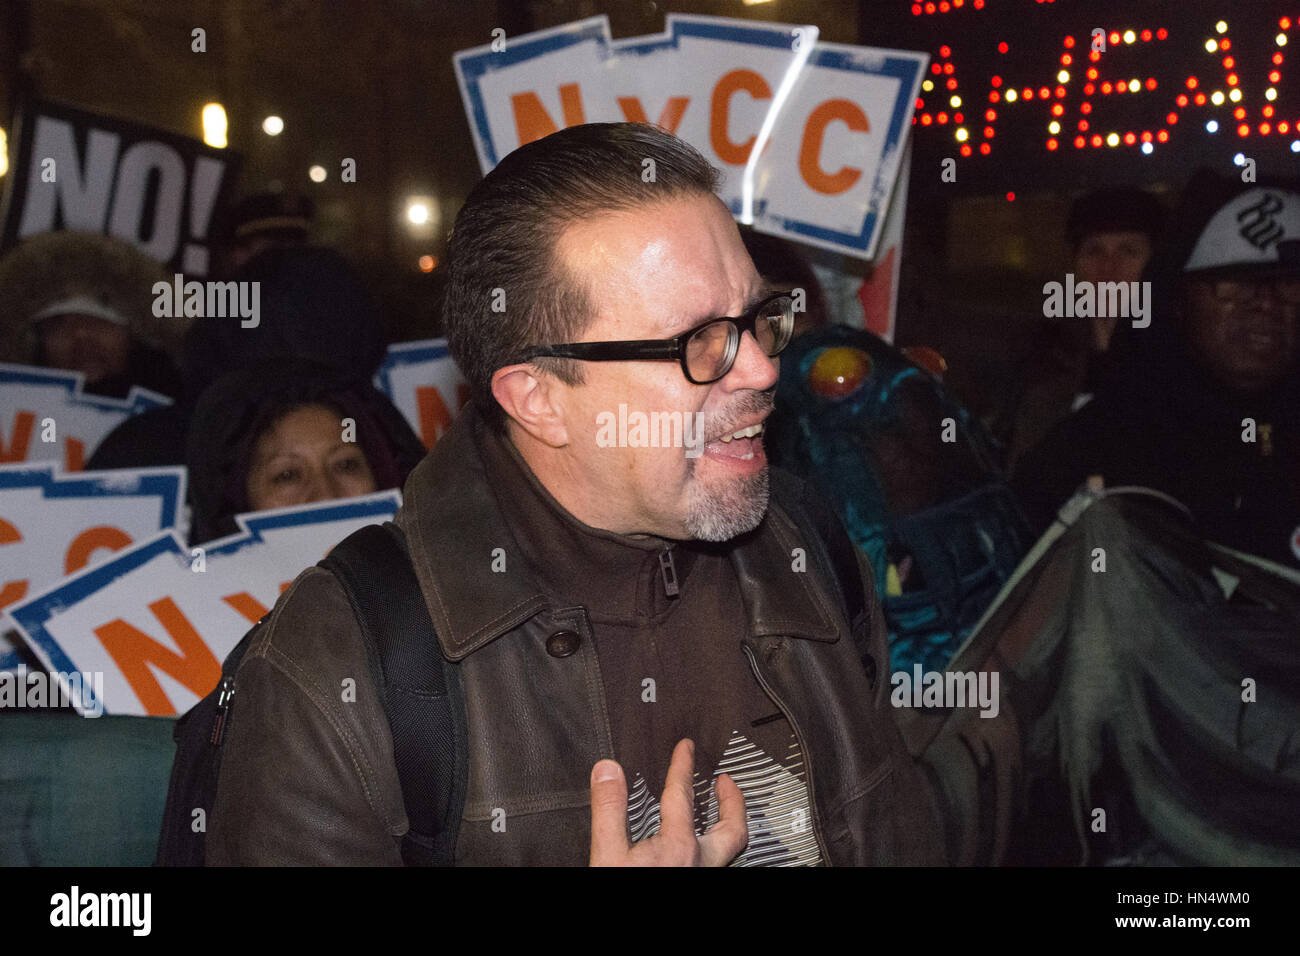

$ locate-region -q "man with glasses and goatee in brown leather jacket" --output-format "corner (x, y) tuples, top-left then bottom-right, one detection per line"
(208, 124), (941, 865)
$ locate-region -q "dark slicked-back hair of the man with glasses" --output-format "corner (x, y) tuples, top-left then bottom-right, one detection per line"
(443, 122), (720, 432)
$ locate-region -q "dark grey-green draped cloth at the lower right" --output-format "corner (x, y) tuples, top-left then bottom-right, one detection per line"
(904, 489), (1300, 865)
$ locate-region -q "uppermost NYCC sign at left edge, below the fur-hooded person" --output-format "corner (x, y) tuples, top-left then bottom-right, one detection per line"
(0, 363), (172, 471)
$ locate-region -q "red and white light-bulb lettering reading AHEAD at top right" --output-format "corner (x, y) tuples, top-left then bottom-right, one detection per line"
(909, 0), (1300, 161)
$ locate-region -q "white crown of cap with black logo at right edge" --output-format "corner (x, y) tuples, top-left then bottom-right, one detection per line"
(1183, 187), (1300, 273)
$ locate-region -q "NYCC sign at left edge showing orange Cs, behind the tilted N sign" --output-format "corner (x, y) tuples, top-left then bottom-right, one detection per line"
(0, 462), (186, 671)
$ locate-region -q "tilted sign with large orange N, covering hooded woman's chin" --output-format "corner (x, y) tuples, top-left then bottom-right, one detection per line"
(7, 490), (400, 715)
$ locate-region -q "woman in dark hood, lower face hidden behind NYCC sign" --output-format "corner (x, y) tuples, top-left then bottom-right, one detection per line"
(185, 359), (424, 545)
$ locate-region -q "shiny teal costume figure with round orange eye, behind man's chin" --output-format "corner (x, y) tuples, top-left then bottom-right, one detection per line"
(763, 325), (1031, 674)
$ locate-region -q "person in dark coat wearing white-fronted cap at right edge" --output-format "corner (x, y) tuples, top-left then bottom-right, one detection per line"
(1013, 173), (1300, 567)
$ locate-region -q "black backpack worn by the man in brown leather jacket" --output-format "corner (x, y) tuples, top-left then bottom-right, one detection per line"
(155, 523), (468, 866)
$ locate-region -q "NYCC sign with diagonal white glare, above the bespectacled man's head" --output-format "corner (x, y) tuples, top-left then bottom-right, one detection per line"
(454, 14), (928, 259)
